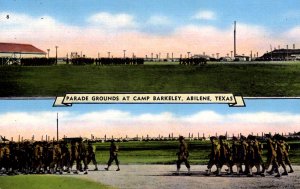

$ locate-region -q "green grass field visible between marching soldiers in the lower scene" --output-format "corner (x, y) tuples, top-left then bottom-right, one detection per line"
(95, 141), (300, 165)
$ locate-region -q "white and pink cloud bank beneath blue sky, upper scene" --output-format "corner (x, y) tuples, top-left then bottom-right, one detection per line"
(0, 12), (300, 57)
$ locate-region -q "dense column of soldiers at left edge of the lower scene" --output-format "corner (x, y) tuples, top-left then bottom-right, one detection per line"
(0, 141), (98, 175)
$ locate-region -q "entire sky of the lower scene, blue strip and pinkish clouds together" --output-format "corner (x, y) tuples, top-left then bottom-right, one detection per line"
(0, 99), (300, 139)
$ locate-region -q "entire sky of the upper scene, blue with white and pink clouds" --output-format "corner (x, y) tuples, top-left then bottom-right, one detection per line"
(0, 0), (300, 57)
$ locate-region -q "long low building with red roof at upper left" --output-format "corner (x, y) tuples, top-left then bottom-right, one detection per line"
(0, 43), (47, 59)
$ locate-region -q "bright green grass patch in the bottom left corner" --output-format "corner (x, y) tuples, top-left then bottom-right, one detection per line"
(0, 175), (112, 189)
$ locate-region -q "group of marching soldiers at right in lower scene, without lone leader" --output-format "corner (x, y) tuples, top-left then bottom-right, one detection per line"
(206, 135), (294, 177)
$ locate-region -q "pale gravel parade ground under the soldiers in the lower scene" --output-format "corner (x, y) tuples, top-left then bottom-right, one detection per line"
(66, 164), (300, 189)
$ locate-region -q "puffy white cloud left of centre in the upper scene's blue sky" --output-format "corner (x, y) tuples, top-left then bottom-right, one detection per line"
(87, 12), (138, 29)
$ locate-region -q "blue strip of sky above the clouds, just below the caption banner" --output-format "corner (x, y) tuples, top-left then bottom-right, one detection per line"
(0, 99), (300, 115)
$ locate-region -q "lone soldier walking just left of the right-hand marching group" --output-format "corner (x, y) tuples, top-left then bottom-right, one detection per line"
(176, 136), (191, 174)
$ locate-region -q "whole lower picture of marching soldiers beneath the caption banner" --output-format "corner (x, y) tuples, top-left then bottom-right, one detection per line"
(0, 98), (300, 189)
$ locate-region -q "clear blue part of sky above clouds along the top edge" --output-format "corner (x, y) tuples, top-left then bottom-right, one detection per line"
(0, 0), (300, 32)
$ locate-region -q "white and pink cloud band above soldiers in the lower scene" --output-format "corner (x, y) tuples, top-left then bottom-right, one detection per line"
(0, 109), (300, 139)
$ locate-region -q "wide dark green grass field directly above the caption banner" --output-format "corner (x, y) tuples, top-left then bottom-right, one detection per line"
(0, 62), (300, 97)
